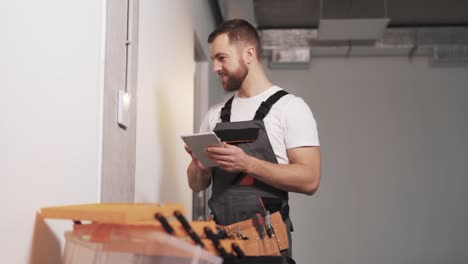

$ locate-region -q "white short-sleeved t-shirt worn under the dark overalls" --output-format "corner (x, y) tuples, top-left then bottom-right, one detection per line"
(200, 86), (320, 164)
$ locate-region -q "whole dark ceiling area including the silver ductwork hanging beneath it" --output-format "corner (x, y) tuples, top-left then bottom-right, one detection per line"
(215, 0), (468, 65)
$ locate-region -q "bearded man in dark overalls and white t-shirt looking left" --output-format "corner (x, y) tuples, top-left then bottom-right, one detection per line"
(186, 19), (321, 258)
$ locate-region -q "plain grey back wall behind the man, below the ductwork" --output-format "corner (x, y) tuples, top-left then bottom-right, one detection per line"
(265, 57), (468, 264)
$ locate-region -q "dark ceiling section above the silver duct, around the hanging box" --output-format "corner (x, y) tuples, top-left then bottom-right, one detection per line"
(253, 0), (468, 29)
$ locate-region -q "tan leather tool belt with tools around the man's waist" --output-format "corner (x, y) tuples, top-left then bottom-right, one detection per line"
(217, 212), (289, 256)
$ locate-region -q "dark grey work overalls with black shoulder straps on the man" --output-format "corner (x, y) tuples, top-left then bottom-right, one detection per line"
(208, 90), (292, 255)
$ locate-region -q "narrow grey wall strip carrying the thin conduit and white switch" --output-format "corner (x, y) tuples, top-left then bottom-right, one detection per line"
(101, 0), (139, 202)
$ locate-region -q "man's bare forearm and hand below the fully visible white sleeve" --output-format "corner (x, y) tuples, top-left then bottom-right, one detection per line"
(208, 144), (321, 195)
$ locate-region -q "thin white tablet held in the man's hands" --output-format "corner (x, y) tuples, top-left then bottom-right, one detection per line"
(180, 132), (223, 167)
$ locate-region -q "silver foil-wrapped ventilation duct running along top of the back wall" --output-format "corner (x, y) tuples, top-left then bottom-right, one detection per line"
(260, 27), (468, 66)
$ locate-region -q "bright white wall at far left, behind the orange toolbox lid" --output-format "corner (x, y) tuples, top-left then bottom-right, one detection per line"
(0, 0), (103, 263)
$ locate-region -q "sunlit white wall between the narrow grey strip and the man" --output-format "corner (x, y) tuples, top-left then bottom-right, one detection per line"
(135, 0), (214, 217)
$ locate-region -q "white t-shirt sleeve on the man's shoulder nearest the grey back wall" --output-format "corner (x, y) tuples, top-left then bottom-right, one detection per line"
(283, 97), (320, 149)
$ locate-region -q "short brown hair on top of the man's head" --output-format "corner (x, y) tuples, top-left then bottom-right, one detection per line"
(208, 19), (260, 60)
